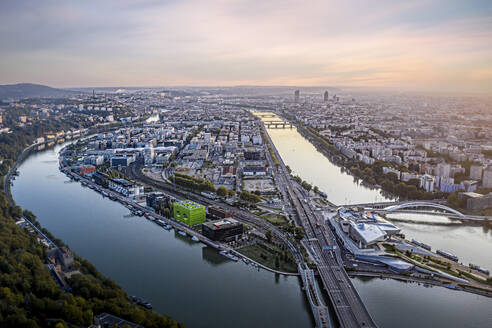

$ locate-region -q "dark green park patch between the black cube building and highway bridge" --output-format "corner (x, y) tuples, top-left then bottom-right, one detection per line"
(237, 244), (297, 272)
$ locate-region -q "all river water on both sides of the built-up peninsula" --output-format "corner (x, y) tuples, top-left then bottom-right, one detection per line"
(12, 125), (492, 328)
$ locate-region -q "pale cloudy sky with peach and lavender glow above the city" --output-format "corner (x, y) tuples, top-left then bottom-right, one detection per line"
(0, 0), (492, 94)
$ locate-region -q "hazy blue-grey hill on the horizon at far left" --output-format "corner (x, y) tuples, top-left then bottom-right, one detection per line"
(0, 83), (78, 99)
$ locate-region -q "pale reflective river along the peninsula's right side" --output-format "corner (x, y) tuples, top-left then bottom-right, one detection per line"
(267, 118), (492, 328)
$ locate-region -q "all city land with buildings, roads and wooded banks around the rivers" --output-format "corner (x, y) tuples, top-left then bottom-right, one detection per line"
(0, 83), (492, 327)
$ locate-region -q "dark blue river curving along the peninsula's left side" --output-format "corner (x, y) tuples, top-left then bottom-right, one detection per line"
(13, 147), (313, 328)
